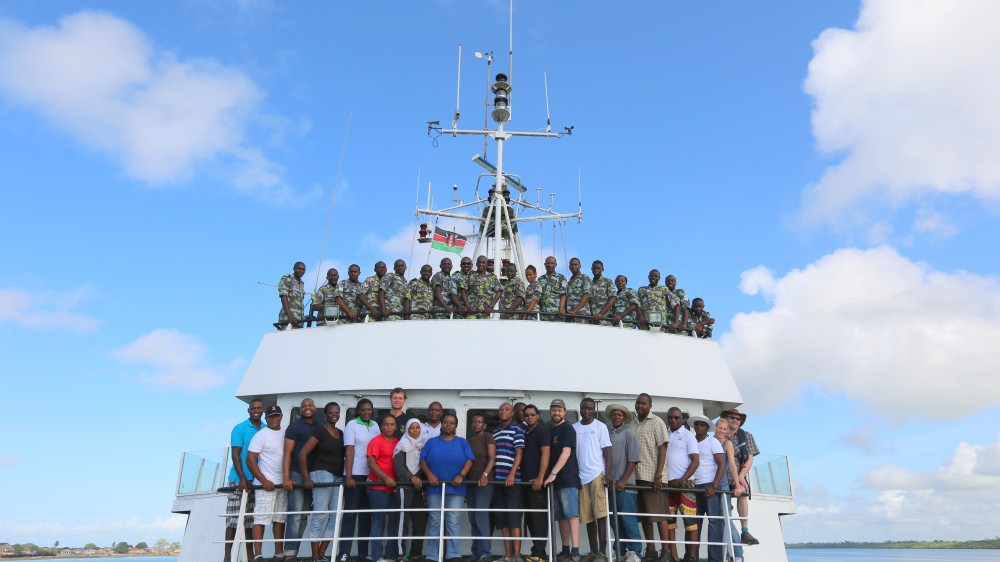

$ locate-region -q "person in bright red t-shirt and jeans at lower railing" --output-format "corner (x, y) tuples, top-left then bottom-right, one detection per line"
(368, 414), (399, 562)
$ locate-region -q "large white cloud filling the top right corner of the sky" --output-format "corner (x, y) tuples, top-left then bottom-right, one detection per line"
(804, 0), (1000, 229)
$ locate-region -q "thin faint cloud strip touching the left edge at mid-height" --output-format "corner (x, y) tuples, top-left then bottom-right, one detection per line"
(0, 287), (101, 332)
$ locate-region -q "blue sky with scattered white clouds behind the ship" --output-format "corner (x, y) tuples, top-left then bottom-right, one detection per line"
(0, 0), (1000, 545)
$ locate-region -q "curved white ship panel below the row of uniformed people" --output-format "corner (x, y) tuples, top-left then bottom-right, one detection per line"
(236, 320), (742, 413)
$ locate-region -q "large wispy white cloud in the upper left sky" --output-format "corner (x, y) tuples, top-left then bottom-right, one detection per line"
(0, 11), (293, 202)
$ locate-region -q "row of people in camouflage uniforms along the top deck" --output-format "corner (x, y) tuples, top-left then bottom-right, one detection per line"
(277, 256), (715, 338)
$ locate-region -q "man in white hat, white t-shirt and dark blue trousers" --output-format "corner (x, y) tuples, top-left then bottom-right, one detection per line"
(688, 416), (726, 562)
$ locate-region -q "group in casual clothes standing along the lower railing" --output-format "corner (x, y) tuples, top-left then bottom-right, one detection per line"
(225, 388), (759, 562)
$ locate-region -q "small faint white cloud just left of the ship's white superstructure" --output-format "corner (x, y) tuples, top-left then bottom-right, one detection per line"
(114, 328), (232, 391)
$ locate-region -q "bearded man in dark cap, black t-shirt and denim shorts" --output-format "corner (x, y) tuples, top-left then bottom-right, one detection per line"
(545, 398), (580, 562)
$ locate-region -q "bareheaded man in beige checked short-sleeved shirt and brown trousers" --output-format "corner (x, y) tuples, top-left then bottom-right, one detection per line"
(635, 392), (670, 562)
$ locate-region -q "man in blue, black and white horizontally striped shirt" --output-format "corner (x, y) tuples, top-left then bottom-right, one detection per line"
(493, 402), (524, 562)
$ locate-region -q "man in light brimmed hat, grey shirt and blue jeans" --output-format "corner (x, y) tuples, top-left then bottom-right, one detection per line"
(604, 404), (642, 562)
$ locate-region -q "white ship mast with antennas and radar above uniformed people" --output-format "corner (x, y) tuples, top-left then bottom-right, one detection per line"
(416, 50), (583, 290)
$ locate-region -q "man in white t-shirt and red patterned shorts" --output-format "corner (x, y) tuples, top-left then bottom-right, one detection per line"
(667, 406), (700, 560)
